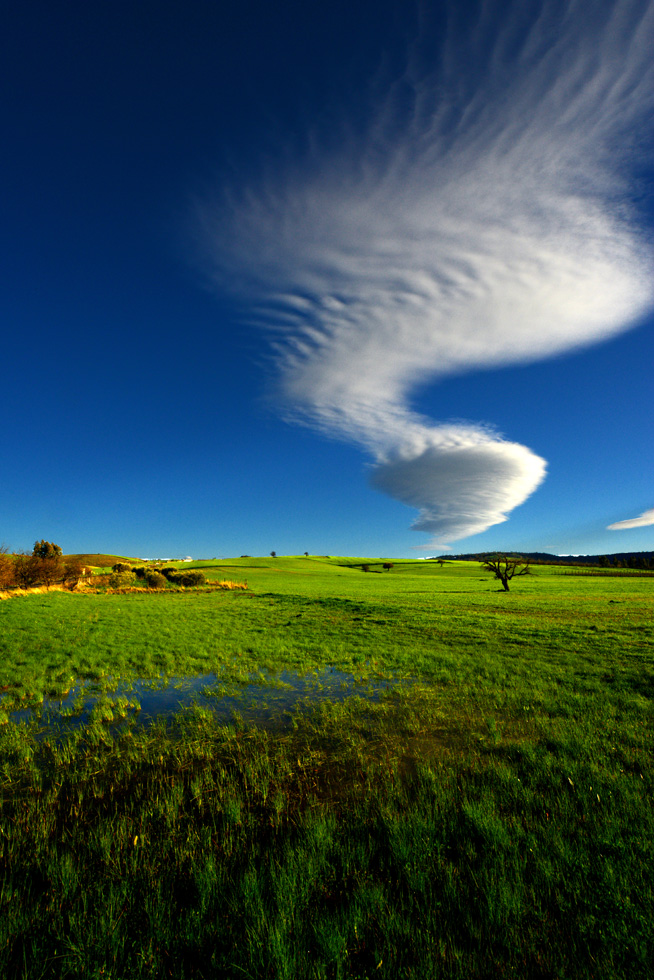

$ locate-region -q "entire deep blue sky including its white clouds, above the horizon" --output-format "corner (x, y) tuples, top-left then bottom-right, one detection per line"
(0, 0), (654, 558)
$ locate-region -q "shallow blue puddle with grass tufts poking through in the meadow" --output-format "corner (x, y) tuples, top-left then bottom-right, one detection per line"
(0, 668), (411, 728)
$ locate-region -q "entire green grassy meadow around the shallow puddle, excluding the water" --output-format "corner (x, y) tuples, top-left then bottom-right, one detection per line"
(0, 556), (654, 980)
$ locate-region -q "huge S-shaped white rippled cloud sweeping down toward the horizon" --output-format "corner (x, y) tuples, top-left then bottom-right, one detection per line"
(198, 0), (654, 544)
